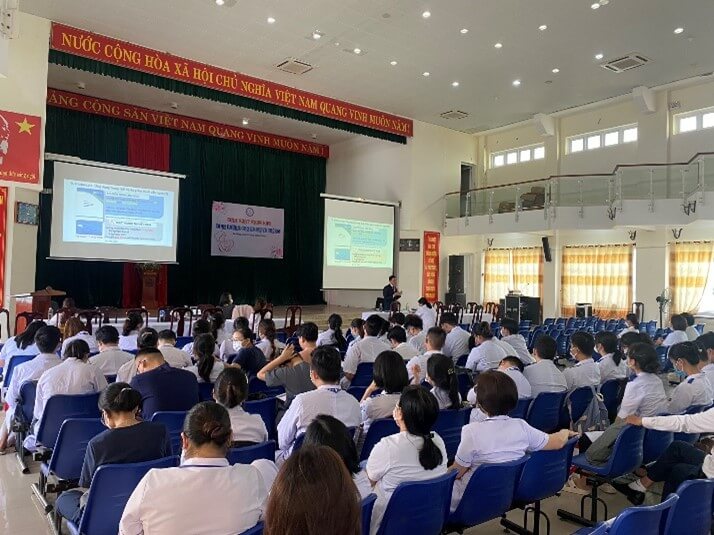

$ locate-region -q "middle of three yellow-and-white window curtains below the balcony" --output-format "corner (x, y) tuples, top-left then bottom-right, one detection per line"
(561, 245), (633, 318)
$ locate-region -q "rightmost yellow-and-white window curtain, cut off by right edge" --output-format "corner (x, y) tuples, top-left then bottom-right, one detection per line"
(669, 242), (713, 313)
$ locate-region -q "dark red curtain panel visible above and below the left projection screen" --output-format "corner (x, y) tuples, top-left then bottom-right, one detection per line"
(122, 128), (171, 308)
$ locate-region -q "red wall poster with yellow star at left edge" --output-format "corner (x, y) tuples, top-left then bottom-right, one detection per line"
(0, 110), (42, 184)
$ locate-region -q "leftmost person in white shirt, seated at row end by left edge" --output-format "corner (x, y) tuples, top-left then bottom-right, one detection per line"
(0, 325), (62, 451)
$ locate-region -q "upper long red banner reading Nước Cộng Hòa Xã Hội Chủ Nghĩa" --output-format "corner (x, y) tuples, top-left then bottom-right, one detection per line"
(50, 23), (414, 136)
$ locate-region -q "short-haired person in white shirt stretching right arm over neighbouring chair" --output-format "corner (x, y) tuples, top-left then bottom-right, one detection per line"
(450, 370), (576, 512)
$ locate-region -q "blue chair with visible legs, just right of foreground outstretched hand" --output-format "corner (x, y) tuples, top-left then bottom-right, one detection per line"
(558, 425), (645, 533)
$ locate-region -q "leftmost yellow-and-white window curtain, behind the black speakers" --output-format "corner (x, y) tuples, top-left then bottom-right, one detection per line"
(483, 247), (543, 303)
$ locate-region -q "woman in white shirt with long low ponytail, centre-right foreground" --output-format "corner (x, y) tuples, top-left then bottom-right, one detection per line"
(366, 386), (447, 534)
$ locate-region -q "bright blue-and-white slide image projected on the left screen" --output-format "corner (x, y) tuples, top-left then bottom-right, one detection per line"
(62, 179), (174, 247)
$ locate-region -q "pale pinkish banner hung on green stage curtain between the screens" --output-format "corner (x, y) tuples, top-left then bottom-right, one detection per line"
(211, 201), (284, 258)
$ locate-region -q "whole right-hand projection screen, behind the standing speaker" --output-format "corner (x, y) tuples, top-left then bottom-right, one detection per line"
(322, 198), (395, 290)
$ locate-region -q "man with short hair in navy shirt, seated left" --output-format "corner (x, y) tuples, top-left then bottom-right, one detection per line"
(131, 347), (198, 420)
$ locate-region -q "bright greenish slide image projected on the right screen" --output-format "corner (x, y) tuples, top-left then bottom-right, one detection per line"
(325, 217), (394, 269)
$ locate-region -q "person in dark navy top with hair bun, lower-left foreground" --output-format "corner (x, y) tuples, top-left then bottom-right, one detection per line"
(55, 383), (171, 524)
